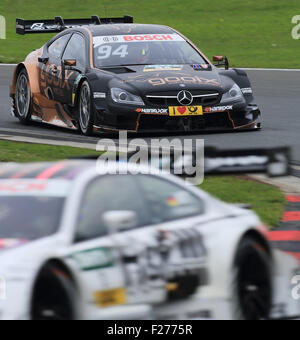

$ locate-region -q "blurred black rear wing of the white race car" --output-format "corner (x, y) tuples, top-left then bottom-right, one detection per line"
(75, 145), (291, 177)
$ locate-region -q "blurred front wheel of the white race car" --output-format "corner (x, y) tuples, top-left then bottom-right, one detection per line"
(31, 266), (79, 320)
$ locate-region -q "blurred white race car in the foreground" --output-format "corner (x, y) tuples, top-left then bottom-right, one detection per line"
(0, 160), (300, 320)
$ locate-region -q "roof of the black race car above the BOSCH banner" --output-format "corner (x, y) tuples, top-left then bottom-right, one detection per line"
(86, 24), (174, 36)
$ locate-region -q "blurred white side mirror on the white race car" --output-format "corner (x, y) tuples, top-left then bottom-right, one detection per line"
(102, 210), (138, 234)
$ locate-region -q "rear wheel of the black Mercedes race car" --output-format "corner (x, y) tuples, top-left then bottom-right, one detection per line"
(13, 68), (32, 124)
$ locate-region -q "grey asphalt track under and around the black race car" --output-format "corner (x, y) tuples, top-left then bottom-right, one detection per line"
(0, 65), (300, 165)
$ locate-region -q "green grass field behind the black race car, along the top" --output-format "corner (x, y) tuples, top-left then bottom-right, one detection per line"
(0, 0), (300, 68)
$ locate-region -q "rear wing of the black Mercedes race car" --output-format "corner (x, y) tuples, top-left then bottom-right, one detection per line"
(16, 15), (133, 35)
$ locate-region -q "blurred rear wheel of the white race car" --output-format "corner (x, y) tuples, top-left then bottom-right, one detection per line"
(233, 236), (272, 320)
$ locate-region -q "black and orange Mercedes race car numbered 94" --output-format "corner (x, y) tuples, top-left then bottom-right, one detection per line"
(11, 16), (261, 135)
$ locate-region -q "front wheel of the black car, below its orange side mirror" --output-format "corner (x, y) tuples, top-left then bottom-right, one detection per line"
(77, 80), (95, 136)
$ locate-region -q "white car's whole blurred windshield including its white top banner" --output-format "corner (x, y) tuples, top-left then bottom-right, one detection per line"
(0, 179), (70, 241)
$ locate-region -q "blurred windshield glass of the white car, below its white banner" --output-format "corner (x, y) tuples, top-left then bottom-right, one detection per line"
(0, 196), (64, 240)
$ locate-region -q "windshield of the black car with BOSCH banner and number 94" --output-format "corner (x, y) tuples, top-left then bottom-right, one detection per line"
(93, 34), (207, 68)
